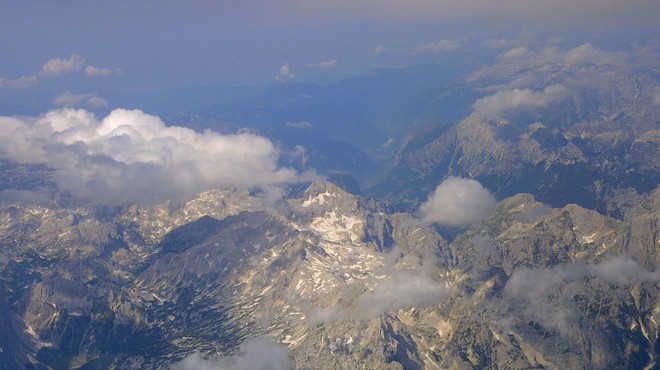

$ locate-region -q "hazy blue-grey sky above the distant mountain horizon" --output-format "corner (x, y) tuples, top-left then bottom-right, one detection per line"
(0, 0), (660, 94)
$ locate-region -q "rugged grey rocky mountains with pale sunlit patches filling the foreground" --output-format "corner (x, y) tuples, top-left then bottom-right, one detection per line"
(0, 182), (660, 369)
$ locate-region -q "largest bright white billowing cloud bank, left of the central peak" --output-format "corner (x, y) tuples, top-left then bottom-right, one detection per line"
(0, 109), (299, 205)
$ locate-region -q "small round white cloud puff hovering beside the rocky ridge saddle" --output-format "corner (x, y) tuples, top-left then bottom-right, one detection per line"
(419, 176), (495, 226)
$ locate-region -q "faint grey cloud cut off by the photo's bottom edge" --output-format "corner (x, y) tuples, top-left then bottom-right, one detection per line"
(174, 337), (293, 370)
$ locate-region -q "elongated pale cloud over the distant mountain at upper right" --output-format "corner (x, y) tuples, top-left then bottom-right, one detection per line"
(472, 84), (570, 118)
